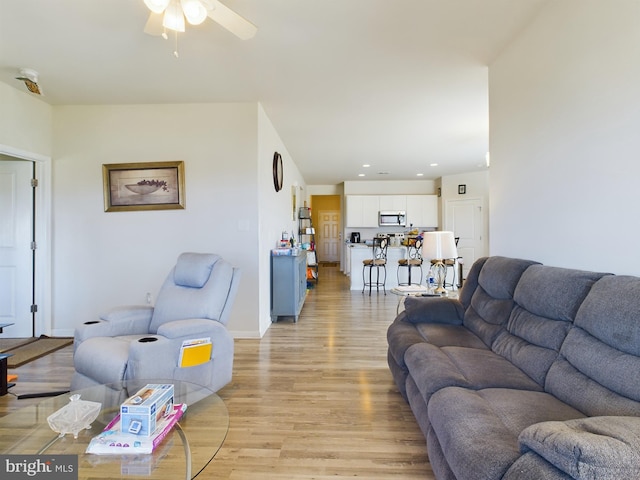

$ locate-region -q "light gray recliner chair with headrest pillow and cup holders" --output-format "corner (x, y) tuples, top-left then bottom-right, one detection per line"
(71, 253), (240, 392)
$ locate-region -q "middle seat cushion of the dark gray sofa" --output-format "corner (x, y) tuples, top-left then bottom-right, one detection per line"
(405, 343), (542, 403)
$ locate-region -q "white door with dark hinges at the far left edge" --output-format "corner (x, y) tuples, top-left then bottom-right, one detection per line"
(0, 160), (33, 337)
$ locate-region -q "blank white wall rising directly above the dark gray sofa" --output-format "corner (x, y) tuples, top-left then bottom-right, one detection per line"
(489, 0), (640, 275)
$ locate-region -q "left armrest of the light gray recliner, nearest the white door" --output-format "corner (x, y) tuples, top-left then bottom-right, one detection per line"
(74, 305), (153, 345)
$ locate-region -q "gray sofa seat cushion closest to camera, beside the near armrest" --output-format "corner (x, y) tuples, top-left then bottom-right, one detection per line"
(428, 387), (584, 480)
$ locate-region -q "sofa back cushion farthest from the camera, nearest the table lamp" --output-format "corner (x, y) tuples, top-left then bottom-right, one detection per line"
(461, 256), (537, 346)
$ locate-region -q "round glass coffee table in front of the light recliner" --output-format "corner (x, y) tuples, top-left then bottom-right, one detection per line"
(0, 379), (229, 480)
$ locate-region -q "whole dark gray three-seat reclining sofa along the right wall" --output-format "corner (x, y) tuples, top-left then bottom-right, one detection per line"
(387, 257), (640, 480)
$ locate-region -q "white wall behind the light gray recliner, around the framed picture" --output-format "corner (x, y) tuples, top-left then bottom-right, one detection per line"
(53, 103), (268, 336)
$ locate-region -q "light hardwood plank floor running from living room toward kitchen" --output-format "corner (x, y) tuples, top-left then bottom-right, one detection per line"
(0, 266), (434, 480)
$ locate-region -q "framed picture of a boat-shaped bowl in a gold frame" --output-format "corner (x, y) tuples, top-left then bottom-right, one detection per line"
(102, 161), (185, 212)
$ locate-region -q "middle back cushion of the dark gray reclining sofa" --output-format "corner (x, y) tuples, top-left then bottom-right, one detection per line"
(491, 265), (604, 387)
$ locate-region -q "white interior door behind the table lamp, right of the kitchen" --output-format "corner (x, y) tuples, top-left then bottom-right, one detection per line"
(444, 198), (486, 277)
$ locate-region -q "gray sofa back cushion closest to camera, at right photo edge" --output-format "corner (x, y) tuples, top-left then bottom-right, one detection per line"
(545, 275), (640, 416)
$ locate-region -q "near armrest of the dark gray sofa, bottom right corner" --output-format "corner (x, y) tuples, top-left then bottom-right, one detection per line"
(519, 416), (640, 480)
